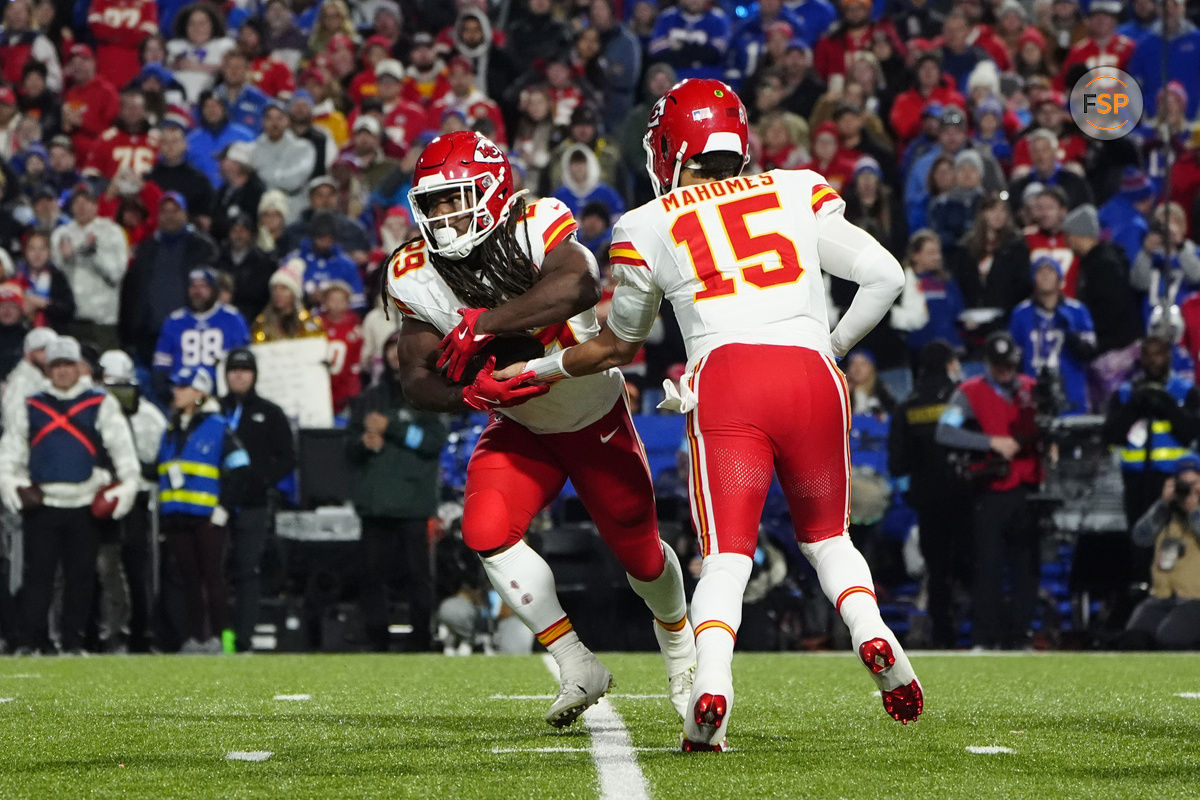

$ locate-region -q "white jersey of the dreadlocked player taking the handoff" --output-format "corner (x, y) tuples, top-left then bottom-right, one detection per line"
(384, 198), (624, 433)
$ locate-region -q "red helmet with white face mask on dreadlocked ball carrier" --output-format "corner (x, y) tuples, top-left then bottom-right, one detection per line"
(408, 131), (521, 261)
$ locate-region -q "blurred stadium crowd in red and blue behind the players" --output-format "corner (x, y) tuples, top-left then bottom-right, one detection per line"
(0, 0), (1200, 650)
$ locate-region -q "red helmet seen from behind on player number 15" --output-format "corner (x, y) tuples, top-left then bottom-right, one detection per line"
(642, 78), (750, 196)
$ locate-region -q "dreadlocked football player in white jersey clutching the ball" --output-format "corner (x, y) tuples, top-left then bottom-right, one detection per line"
(384, 132), (696, 727)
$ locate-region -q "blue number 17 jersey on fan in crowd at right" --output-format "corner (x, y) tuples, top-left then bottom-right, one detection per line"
(1009, 297), (1096, 414)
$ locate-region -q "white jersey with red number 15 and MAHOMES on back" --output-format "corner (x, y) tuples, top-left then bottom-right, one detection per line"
(608, 169), (846, 368)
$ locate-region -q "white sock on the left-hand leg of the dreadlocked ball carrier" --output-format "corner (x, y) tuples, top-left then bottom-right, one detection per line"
(480, 540), (583, 663)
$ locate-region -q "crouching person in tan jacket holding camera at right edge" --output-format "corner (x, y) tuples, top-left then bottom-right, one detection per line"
(1121, 455), (1200, 650)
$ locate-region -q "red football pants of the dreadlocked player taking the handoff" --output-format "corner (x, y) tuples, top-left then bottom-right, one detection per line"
(462, 397), (664, 581)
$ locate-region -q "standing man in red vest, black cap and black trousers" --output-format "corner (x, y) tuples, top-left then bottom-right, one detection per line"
(935, 331), (1042, 649)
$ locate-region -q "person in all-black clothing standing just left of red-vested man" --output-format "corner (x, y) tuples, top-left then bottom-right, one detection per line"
(888, 339), (971, 649)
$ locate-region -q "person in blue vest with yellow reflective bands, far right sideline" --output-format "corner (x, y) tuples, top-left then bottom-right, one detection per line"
(1104, 335), (1200, 528)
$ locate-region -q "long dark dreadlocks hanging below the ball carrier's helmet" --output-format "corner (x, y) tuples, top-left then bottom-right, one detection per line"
(428, 198), (538, 308)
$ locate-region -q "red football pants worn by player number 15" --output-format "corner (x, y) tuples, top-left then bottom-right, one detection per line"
(686, 344), (850, 557)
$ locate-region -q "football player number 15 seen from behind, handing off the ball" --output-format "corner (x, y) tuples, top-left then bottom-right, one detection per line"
(496, 80), (923, 751)
